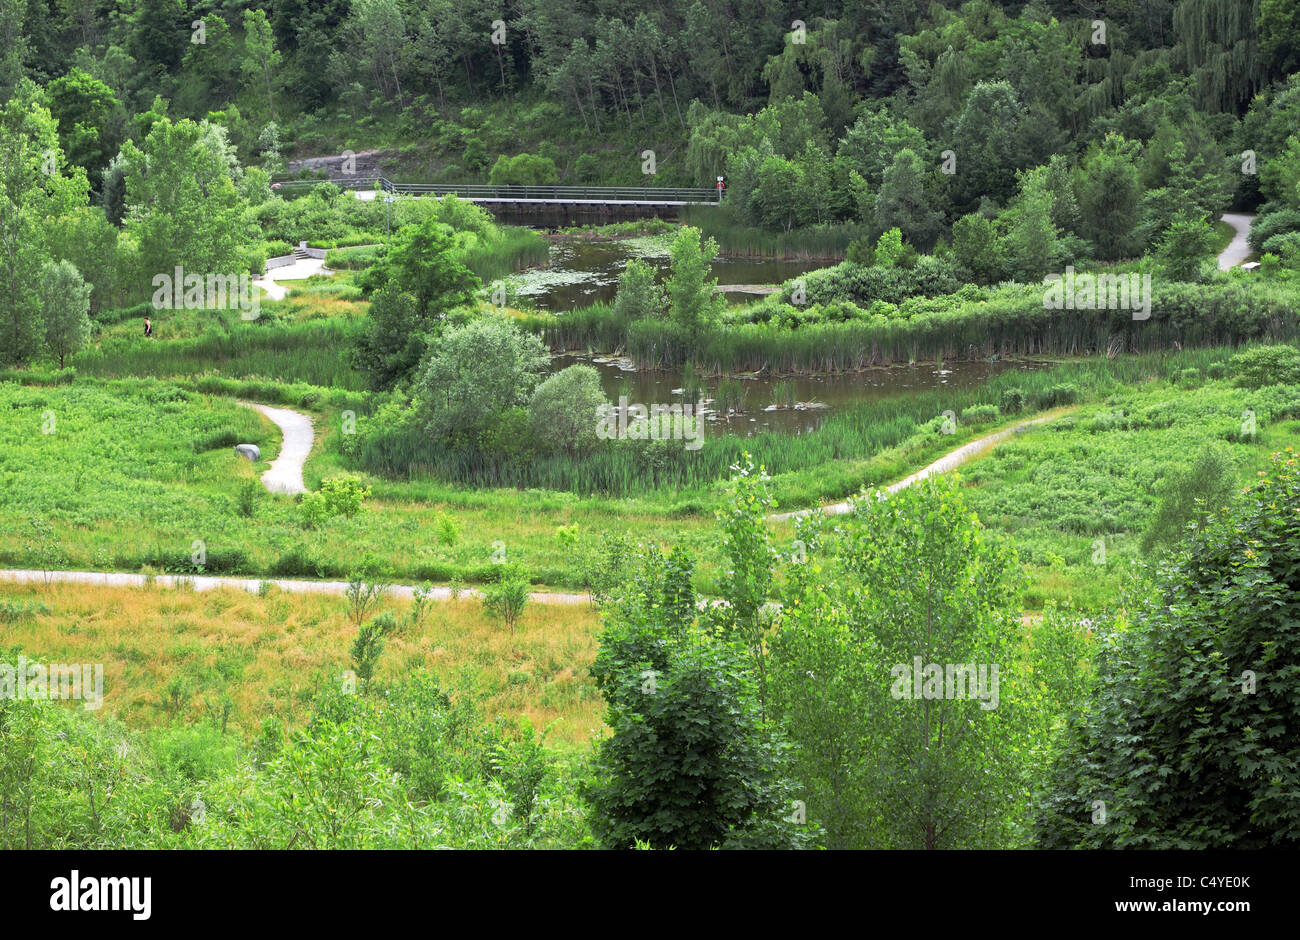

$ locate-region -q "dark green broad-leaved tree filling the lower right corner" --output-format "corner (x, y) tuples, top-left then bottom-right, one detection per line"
(1039, 451), (1300, 849)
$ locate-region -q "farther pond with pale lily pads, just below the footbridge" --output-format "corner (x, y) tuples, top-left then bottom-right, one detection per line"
(506, 235), (827, 313)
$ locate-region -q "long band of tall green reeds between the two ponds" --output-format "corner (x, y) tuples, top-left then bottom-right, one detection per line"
(523, 280), (1300, 374)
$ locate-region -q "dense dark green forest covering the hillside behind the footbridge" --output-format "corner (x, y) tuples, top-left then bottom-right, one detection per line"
(0, 0), (1300, 196)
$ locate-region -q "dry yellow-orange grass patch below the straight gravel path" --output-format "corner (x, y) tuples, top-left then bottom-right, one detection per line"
(0, 584), (603, 746)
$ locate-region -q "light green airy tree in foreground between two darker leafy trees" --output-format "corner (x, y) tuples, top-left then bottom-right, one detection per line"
(771, 477), (1043, 849)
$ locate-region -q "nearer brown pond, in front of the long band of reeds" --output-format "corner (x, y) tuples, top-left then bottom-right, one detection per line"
(551, 355), (1050, 437)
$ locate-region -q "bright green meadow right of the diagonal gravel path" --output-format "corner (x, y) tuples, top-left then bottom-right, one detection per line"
(961, 381), (1300, 608)
